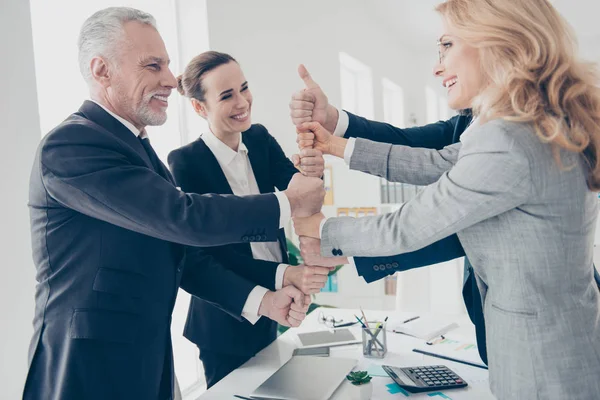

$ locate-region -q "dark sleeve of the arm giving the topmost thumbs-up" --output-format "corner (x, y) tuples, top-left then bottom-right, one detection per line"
(344, 112), (459, 150)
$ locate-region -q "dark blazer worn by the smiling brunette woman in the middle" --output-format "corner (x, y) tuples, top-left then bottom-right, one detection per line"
(168, 124), (298, 356)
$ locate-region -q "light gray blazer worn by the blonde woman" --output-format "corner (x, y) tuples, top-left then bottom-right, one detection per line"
(321, 120), (600, 400)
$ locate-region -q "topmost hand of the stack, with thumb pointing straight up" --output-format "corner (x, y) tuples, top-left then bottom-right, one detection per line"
(290, 64), (339, 132)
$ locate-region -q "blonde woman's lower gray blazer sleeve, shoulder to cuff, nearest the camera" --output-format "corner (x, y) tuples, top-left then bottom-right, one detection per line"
(321, 121), (533, 256)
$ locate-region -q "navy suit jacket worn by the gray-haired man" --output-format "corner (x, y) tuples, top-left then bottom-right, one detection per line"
(23, 101), (280, 400)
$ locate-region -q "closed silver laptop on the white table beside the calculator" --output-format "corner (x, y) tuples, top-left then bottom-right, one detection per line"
(250, 356), (358, 400)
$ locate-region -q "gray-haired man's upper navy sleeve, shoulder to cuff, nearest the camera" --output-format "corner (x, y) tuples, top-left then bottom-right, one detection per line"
(39, 124), (279, 246)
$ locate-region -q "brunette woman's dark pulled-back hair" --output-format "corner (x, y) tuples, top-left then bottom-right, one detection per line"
(177, 51), (237, 101)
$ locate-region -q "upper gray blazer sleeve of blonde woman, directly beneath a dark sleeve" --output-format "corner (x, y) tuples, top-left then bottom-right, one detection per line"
(350, 138), (461, 186)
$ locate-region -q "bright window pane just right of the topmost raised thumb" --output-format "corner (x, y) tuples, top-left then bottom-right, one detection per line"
(340, 52), (373, 119)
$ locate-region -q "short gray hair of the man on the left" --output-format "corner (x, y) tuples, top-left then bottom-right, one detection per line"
(77, 7), (156, 83)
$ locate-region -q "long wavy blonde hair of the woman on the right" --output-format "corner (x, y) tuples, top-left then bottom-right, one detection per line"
(436, 0), (600, 191)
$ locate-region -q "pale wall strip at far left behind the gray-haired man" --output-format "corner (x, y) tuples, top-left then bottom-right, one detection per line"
(0, 0), (40, 399)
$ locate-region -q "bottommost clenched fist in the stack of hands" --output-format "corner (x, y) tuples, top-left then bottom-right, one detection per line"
(258, 286), (310, 327)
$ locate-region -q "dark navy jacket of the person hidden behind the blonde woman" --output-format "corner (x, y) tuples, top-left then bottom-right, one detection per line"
(344, 109), (600, 364)
